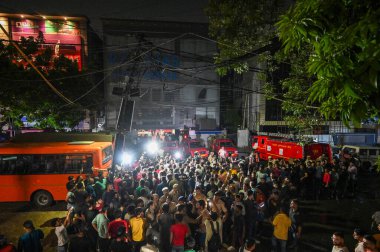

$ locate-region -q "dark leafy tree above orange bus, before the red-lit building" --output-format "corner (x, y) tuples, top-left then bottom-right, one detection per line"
(0, 34), (102, 129)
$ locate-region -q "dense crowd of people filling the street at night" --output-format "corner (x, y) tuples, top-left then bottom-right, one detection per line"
(0, 148), (377, 252)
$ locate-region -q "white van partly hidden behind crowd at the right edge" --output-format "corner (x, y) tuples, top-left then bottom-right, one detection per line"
(342, 145), (380, 169)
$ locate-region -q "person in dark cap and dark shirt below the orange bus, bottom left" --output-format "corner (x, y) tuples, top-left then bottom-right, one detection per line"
(17, 220), (44, 252)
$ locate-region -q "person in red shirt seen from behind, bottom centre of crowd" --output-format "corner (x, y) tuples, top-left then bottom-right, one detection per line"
(170, 213), (190, 252)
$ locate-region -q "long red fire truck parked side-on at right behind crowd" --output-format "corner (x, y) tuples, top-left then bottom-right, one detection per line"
(252, 136), (332, 162)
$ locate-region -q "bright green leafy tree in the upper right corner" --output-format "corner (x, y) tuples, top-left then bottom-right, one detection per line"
(277, 0), (380, 124)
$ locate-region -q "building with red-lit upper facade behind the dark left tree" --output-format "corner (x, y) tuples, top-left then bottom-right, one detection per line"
(0, 11), (103, 131)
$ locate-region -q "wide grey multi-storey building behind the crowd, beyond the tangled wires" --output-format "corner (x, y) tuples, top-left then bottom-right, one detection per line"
(102, 18), (219, 129)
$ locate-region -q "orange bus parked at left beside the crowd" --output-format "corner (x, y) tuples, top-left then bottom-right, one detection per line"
(0, 141), (113, 207)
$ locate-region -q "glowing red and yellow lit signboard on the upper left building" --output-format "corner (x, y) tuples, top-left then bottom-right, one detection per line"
(11, 18), (82, 70)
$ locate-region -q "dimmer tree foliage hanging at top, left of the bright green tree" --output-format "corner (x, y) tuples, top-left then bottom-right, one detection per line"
(206, 0), (283, 75)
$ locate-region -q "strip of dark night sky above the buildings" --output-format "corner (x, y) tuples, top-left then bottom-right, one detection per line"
(0, 0), (208, 32)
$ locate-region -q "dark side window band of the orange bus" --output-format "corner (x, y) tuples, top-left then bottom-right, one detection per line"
(0, 154), (93, 175)
